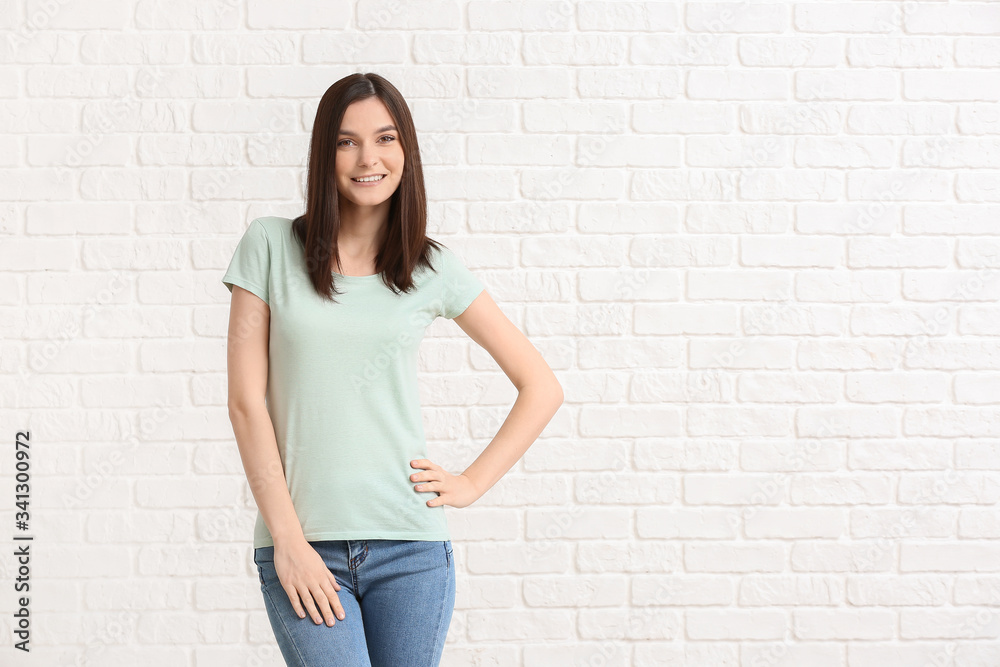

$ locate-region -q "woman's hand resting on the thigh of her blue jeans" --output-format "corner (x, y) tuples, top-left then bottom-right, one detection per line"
(274, 539), (345, 626)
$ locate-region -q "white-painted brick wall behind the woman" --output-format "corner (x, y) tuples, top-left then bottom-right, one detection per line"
(0, 0), (1000, 667)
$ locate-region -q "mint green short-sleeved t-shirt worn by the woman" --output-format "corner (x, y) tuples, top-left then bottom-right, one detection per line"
(222, 217), (483, 548)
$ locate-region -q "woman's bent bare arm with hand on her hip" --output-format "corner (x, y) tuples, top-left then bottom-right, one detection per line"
(410, 290), (563, 507)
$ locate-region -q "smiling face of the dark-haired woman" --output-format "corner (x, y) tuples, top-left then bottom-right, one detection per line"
(334, 97), (405, 206)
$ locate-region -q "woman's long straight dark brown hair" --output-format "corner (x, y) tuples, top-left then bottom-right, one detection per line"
(292, 72), (441, 302)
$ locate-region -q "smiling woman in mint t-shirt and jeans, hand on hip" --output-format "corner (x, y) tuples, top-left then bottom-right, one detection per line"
(223, 74), (563, 667)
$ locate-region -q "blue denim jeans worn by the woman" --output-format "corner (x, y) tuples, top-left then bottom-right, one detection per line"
(253, 540), (455, 667)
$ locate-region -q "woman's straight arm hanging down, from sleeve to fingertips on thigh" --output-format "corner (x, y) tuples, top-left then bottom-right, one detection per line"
(226, 285), (344, 625)
